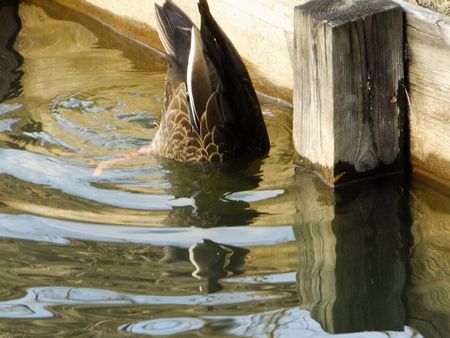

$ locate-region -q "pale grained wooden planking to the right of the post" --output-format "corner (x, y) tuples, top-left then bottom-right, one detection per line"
(394, 2), (450, 184)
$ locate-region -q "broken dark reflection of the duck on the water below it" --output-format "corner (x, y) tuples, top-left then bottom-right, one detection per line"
(157, 161), (260, 293)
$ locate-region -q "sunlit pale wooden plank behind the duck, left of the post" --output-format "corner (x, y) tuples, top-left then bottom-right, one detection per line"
(55, 0), (307, 100)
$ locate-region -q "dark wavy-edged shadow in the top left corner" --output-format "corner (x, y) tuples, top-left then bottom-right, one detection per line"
(0, 0), (23, 102)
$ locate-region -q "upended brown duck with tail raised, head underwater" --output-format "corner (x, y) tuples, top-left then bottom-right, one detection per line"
(151, 0), (270, 163)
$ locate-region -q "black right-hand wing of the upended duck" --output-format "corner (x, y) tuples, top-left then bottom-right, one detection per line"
(198, 0), (270, 157)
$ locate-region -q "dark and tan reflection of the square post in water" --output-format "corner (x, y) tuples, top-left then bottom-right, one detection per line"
(294, 173), (411, 333)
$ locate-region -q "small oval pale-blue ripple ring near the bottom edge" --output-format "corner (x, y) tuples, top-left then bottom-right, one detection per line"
(119, 317), (205, 336)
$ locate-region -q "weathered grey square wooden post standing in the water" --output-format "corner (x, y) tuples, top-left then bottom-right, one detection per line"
(293, 0), (405, 185)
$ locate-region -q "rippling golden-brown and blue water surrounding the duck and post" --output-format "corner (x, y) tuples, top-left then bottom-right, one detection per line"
(0, 1), (450, 338)
